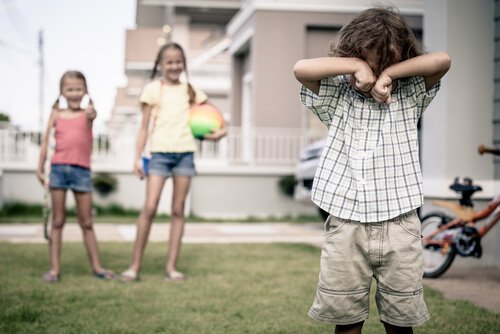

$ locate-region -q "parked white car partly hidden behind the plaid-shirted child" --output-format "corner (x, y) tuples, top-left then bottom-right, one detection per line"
(294, 139), (328, 219)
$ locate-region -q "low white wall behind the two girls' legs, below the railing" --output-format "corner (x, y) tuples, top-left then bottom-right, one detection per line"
(0, 167), (317, 219)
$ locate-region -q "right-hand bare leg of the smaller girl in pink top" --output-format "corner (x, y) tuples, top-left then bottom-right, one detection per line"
(74, 191), (104, 273)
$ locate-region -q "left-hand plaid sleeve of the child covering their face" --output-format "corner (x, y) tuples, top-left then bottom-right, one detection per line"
(300, 77), (342, 127)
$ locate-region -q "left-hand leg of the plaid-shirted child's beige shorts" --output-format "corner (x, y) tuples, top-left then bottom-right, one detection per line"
(308, 216), (373, 330)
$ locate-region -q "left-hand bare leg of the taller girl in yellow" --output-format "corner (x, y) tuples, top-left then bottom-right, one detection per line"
(128, 175), (167, 272)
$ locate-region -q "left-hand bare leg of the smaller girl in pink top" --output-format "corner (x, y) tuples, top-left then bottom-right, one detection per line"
(49, 189), (66, 276)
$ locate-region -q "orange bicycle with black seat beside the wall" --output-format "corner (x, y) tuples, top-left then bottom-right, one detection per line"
(421, 145), (500, 278)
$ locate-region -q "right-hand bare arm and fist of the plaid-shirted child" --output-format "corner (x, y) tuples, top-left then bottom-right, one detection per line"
(371, 51), (451, 103)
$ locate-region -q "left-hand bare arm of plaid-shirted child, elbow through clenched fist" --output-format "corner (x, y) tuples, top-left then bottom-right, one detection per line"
(293, 57), (376, 94)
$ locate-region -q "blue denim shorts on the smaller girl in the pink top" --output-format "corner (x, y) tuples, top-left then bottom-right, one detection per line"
(49, 165), (93, 193)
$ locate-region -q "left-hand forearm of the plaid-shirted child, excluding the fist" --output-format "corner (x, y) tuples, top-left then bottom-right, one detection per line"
(293, 57), (360, 83)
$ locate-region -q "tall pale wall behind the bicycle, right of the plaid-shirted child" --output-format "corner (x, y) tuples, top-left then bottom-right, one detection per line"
(421, 0), (495, 197)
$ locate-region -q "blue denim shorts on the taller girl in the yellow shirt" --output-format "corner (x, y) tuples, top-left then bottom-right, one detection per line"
(148, 152), (196, 176)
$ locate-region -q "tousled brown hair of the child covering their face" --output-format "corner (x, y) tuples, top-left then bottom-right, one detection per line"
(330, 8), (424, 76)
